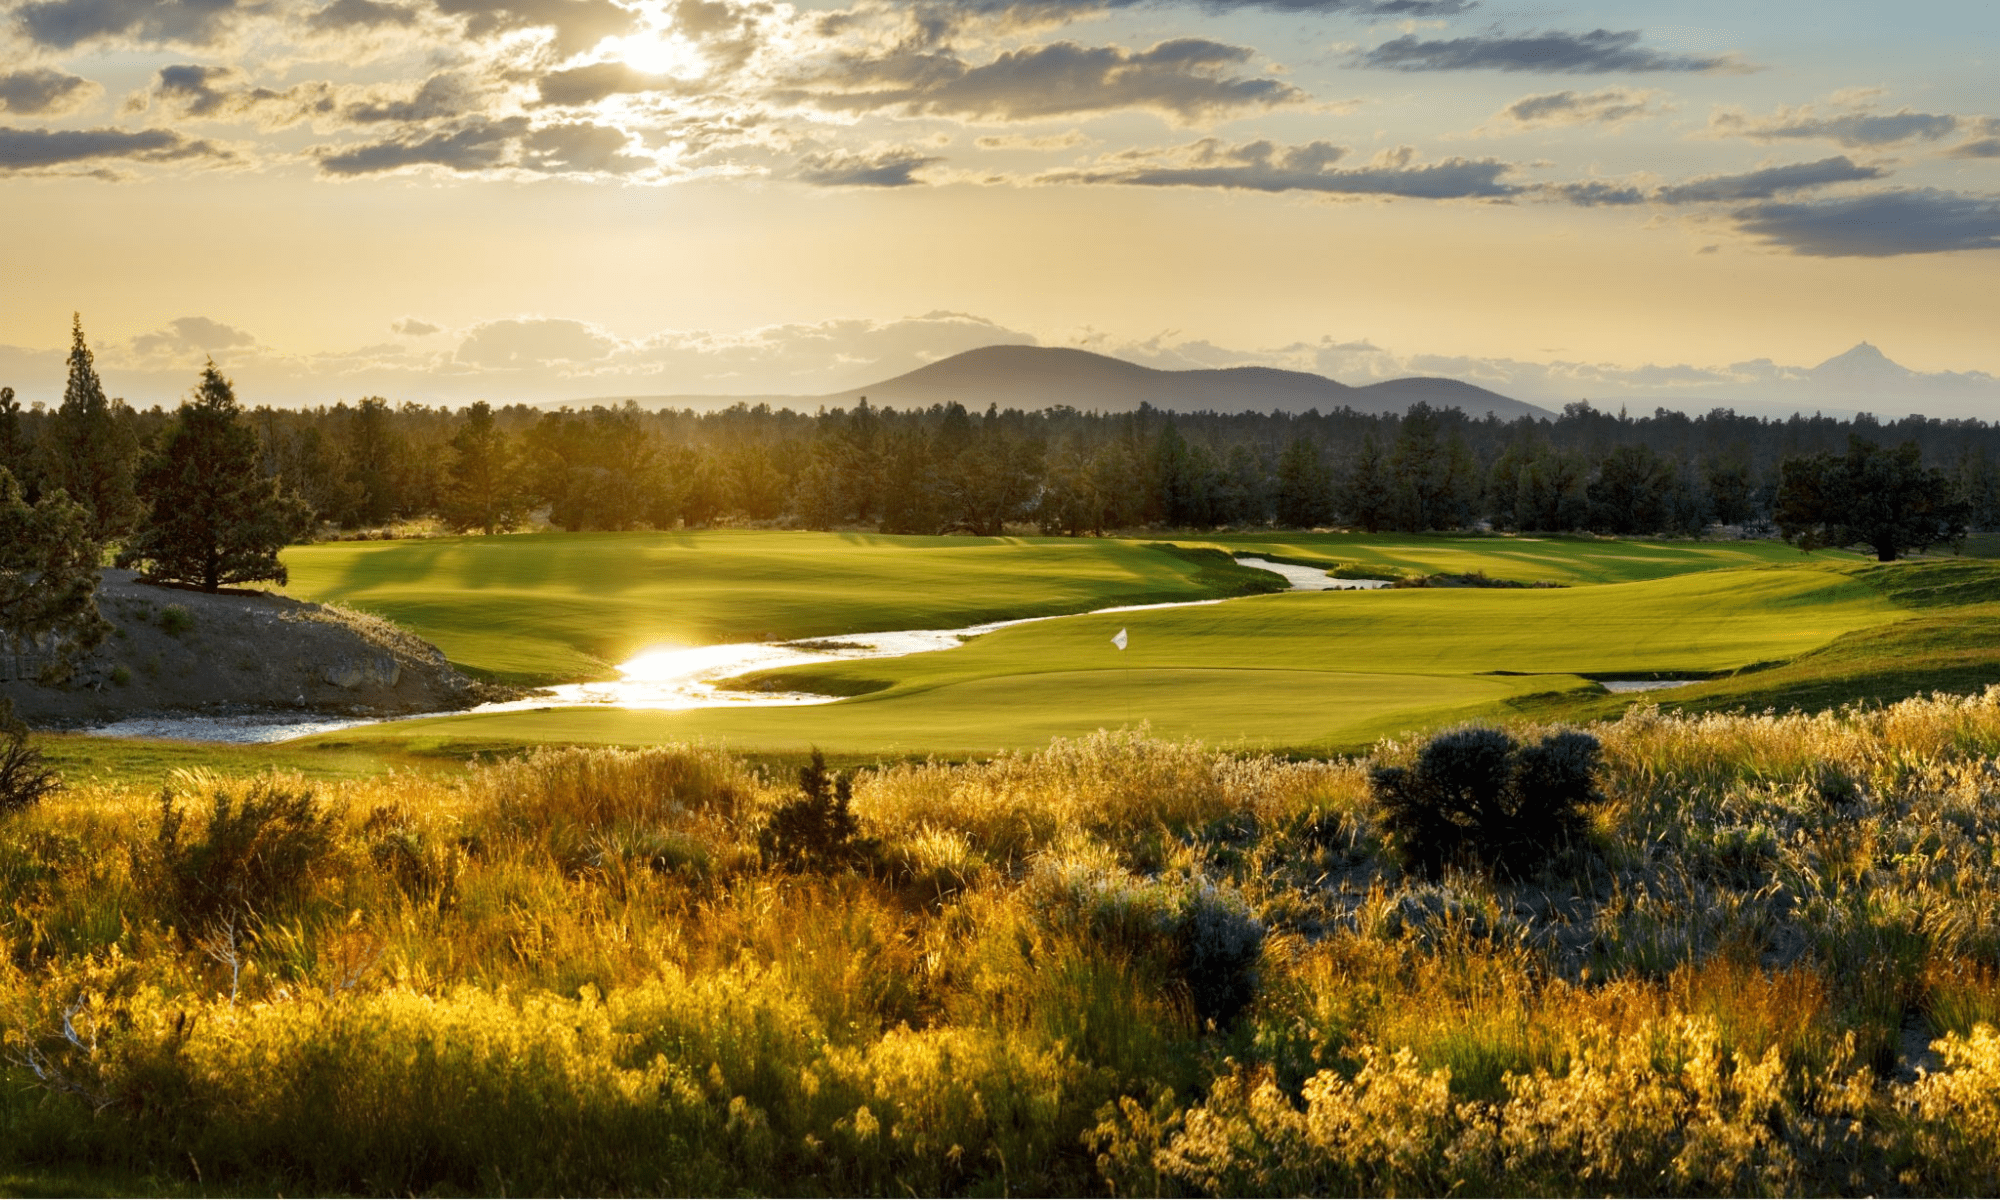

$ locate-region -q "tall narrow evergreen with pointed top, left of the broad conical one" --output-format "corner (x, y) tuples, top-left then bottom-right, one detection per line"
(42, 316), (140, 542)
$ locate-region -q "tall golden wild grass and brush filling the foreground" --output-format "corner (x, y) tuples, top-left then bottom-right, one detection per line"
(11, 704), (2000, 1194)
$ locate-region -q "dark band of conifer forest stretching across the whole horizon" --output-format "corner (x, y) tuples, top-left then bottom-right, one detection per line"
(0, 324), (2000, 624)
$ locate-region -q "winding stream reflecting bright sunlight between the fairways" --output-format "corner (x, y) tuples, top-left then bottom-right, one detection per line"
(84, 556), (1388, 742)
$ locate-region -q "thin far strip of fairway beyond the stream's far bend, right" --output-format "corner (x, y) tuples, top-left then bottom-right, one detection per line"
(1176, 534), (1832, 584)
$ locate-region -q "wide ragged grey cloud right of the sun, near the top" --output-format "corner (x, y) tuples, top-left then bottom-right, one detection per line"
(798, 38), (1306, 122)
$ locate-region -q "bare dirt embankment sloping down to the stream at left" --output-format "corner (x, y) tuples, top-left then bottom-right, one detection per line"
(0, 570), (512, 728)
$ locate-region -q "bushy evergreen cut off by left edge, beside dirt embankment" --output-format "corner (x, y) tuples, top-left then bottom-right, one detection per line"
(0, 468), (110, 656)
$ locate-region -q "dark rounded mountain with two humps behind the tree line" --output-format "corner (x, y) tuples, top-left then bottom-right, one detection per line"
(580, 346), (1554, 420)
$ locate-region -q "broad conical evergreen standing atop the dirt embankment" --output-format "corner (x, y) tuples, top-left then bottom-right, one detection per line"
(118, 362), (312, 592)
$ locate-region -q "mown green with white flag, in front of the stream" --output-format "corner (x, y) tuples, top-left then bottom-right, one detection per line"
(320, 570), (1898, 754)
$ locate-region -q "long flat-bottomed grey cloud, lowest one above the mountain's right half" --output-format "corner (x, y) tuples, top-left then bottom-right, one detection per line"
(1038, 138), (1522, 200)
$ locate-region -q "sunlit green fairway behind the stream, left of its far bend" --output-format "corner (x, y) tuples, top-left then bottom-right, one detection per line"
(284, 530), (1274, 684)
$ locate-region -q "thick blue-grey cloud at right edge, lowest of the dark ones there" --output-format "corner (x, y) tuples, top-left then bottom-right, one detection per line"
(1732, 188), (2000, 258)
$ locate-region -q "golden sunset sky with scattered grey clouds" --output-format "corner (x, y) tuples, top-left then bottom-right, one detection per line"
(0, 0), (2000, 418)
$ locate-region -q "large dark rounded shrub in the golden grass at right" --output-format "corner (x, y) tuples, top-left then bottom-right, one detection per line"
(1370, 730), (1602, 878)
